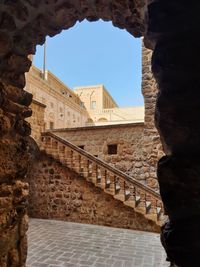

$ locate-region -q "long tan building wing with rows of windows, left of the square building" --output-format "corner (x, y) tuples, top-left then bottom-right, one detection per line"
(26, 66), (89, 130)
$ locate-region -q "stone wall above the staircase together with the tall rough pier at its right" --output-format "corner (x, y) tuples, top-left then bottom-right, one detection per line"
(52, 46), (163, 193)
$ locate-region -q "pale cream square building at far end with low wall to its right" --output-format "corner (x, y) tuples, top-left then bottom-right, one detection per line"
(74, 85), (144, 126)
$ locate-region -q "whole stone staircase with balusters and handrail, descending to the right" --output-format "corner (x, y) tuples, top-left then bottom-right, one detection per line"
(42, 132), (165, 226)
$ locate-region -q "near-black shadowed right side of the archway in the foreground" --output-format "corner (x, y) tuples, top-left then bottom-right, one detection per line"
(148, 0), (200, 267)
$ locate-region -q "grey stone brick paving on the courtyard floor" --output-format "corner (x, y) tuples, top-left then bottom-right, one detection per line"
(27, 219), (169, 267)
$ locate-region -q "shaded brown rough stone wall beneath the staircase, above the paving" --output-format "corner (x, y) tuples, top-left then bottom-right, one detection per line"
(28, 155), (159, 231)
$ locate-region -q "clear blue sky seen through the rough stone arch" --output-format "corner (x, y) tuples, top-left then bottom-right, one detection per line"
(33, 21), (143, 107)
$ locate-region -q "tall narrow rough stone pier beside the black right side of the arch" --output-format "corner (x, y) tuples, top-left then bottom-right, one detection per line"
(140, 45), (164, 188)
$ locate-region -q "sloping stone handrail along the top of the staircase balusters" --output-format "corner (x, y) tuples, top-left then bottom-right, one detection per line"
(42, 131), (161, 201)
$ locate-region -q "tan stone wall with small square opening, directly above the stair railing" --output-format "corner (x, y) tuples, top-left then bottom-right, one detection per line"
(54, 123), (144, 174)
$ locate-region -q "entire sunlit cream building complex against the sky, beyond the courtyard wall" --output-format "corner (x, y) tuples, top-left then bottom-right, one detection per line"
(26, 66), (144, 136)
